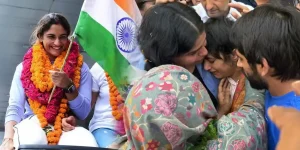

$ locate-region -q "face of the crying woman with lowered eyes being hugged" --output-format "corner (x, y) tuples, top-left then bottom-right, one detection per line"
(204, 54), (237, 79)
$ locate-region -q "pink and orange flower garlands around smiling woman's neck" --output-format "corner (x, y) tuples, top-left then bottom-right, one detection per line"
(21, 42), (83, 145)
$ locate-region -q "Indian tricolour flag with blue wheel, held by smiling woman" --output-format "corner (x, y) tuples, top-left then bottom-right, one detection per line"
(75, 0), (144, 87)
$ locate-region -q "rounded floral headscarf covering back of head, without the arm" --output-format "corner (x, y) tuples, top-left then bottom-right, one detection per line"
(119, 65), (217, 150)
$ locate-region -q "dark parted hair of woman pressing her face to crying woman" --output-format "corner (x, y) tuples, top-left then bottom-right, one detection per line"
(137, 2), (204, 70)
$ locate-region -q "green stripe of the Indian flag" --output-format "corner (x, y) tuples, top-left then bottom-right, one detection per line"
(75, 11), (131, 88)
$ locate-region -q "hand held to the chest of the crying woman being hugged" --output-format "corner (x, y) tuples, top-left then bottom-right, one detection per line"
(218, 79), (232, 119)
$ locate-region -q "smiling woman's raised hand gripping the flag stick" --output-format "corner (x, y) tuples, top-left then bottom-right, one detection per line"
(49, 69), (72, 88)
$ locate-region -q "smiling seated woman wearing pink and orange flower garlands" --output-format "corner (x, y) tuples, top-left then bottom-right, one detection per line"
(1, 13), (97, 149)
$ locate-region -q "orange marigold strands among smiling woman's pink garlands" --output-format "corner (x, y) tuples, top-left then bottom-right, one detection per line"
(28, 42), (83, 145)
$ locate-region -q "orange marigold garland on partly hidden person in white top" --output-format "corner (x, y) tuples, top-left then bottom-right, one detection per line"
(105, 73), (124, 121)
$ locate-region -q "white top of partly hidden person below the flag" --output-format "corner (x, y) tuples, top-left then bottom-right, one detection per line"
(89, 63), (116, 132)
